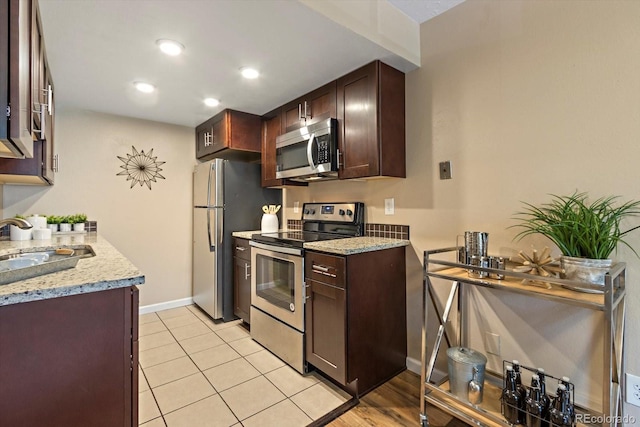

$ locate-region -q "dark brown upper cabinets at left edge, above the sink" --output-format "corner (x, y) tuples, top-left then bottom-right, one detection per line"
(0, 0), (58, 185)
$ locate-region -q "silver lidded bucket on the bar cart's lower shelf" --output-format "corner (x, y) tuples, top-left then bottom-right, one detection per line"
(447, 347), (487, 404)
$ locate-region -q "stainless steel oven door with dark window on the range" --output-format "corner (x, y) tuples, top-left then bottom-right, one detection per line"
(250, 241), (304, 332)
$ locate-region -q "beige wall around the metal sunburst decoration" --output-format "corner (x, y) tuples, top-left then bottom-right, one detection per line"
(3, 111), (195, 306)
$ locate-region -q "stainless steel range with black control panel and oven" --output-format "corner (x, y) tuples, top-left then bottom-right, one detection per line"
(250, 202), (364, 373)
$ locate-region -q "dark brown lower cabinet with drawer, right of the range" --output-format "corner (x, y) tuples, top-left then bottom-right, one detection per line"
(305, 247), (407, 395)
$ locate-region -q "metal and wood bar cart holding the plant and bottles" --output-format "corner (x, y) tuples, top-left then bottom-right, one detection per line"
(420, 247), (626, 427)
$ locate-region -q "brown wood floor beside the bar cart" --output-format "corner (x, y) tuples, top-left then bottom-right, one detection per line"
(327, 371), (467, 427)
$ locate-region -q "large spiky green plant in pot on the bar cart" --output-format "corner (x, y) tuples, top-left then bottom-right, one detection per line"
(513, 191), (640, 284)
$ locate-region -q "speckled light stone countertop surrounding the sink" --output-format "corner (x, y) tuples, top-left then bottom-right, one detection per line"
(0, 233), (144, 306)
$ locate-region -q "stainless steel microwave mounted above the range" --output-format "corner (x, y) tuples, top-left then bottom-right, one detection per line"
(276, 119), (338, 181)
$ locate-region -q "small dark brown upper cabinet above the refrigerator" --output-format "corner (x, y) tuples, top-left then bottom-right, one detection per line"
(196, 109), (262, 162)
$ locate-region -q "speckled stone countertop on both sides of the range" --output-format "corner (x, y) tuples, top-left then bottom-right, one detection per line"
(232, 230), (411, 255)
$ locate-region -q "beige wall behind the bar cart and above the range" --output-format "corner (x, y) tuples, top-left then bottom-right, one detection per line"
(286, 0), (640, 419)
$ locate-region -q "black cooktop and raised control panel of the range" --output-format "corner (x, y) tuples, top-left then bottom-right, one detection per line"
(251, 202), (364, 248)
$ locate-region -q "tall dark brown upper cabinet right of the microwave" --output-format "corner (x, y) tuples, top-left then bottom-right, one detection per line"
(337, 61), (406, 179)
